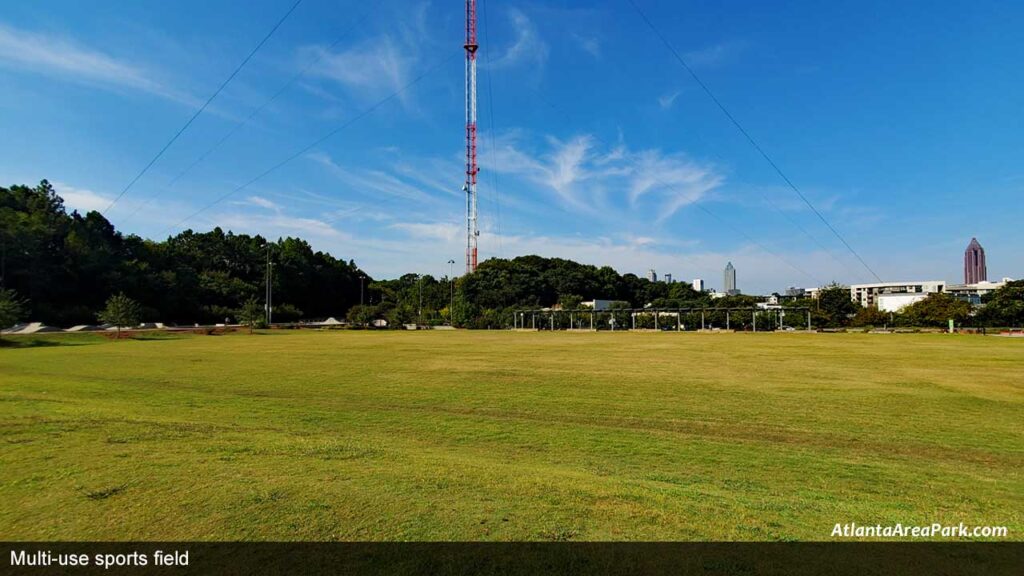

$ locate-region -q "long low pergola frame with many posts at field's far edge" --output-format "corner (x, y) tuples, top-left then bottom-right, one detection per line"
(512, 306), (813, 332)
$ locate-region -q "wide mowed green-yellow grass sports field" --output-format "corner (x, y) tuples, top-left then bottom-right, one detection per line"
(0, 331), (1024, 540)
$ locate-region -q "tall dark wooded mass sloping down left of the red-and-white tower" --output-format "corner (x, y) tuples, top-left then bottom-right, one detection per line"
(0, 180), (371, 326)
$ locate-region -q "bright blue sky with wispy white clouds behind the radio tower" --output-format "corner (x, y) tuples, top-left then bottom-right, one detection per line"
(0, 0), (1024, 292)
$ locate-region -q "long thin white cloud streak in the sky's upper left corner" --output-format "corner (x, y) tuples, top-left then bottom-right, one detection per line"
(0, 25), (198, 106)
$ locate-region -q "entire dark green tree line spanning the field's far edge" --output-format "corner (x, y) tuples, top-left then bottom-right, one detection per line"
(0, 180), (1024, 329)
